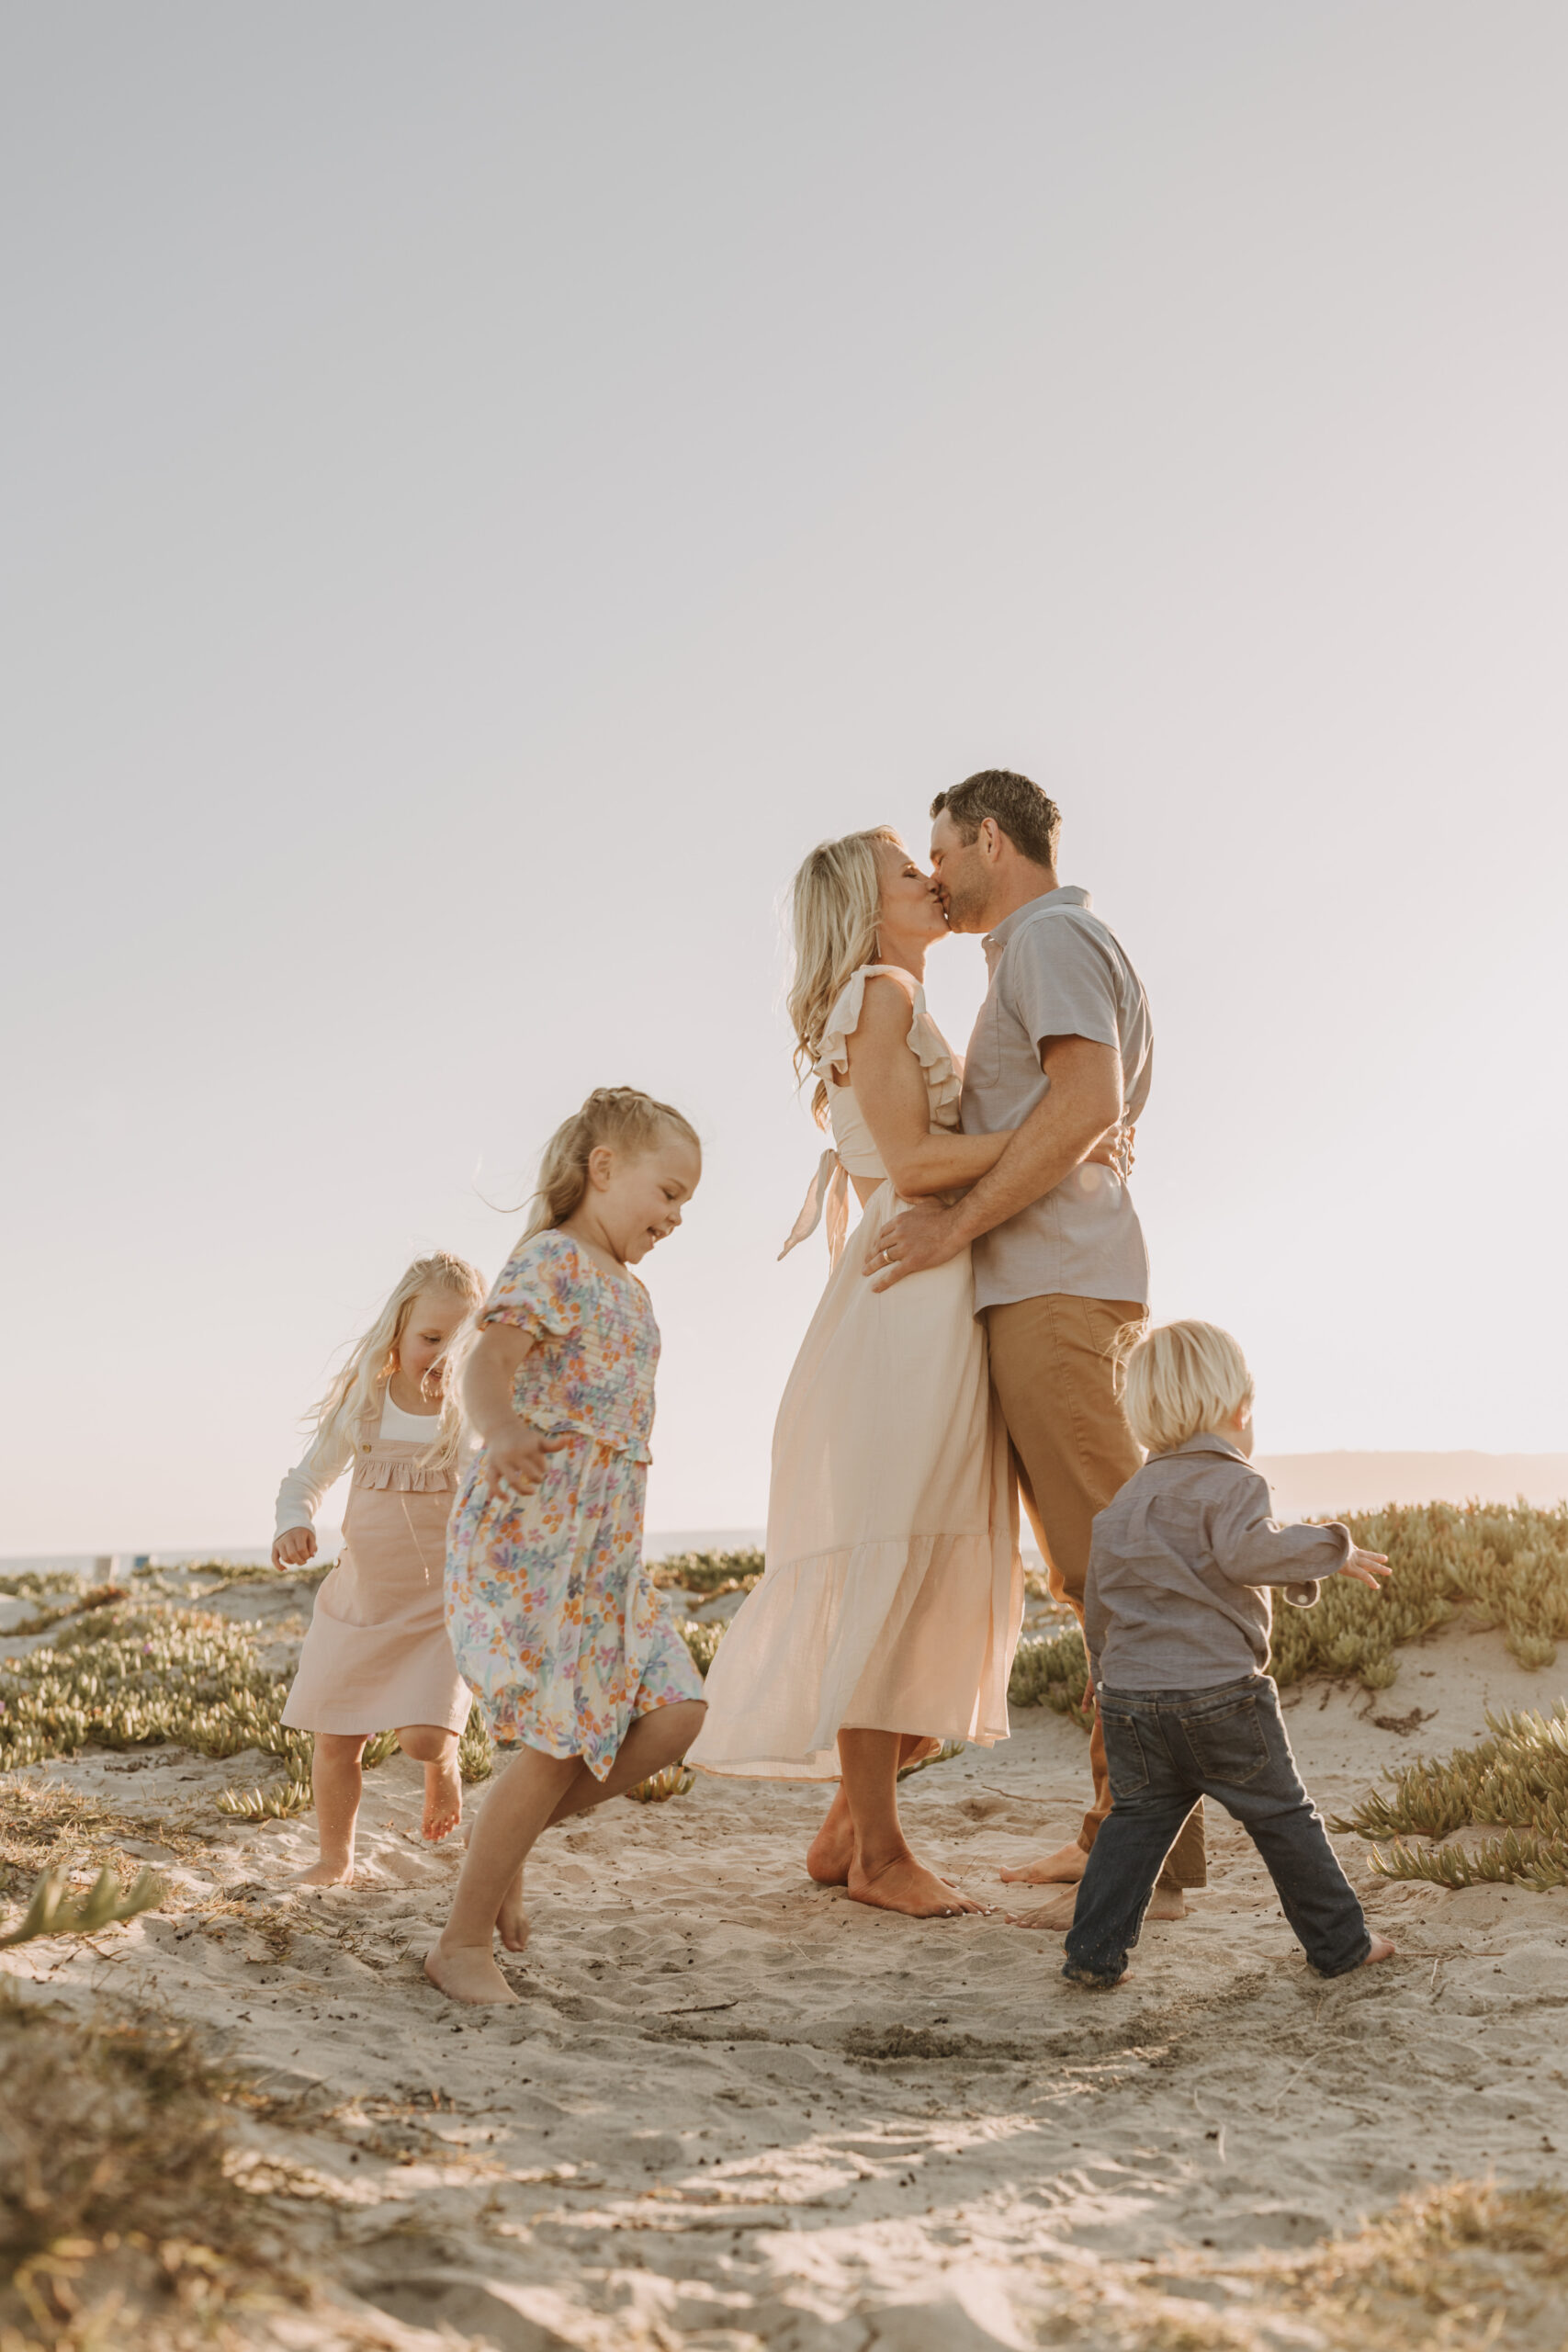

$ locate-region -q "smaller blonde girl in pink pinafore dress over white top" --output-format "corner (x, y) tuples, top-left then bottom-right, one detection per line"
(273, 1251), (484, 1886)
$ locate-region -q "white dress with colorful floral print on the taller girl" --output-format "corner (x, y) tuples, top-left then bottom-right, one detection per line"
(446, 1230), (703, 1781)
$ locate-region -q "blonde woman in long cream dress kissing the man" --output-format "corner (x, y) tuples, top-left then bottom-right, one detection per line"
(689, 826), (1022, 1919)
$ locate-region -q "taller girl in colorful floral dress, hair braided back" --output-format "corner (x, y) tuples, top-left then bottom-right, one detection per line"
(425, 1087), (703, 2002)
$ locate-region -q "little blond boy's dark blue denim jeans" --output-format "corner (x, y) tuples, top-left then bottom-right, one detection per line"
(1063, 1675), (1371, 1985)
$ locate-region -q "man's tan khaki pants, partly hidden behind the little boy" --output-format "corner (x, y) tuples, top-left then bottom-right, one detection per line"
(985, 1291), (1208, 1886)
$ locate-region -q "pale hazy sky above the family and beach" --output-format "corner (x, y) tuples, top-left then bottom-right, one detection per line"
(0, 0), (1568, 1553)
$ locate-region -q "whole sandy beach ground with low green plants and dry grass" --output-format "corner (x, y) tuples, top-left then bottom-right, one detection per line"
(0, 1508), (1568, 2352)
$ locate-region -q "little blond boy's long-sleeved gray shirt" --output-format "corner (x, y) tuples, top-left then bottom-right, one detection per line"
(1084, 1432), (1352, 1691)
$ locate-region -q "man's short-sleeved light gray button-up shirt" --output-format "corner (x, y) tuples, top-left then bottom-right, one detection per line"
(962, 887), (1155, 1312)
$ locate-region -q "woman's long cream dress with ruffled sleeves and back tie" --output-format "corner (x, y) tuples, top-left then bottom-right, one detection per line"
(686, 965), (1022, 1781)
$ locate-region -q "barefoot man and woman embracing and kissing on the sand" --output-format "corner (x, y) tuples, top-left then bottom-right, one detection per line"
(689, 769), (1206, 1927)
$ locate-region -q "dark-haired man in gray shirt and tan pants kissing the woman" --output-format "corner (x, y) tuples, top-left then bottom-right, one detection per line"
(867, 769), (1206, 1927)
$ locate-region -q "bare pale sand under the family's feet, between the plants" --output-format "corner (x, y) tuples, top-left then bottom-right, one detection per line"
(3, 1595), (1568, 2352)
